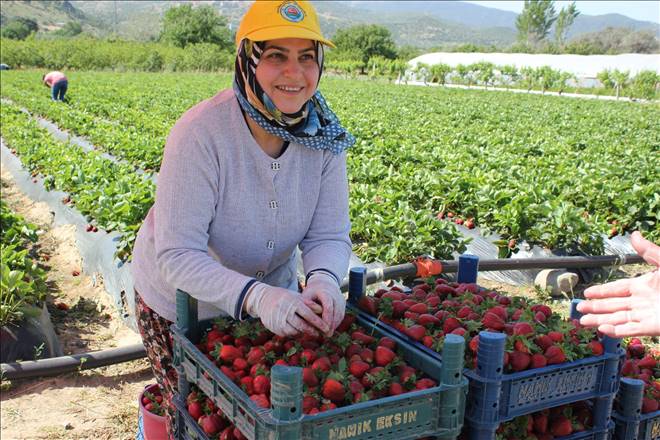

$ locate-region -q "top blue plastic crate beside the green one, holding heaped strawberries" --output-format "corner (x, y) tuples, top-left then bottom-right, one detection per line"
(349, 266), (622, 439)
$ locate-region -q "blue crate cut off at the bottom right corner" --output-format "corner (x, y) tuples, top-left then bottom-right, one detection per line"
(612, 377), (660, 440)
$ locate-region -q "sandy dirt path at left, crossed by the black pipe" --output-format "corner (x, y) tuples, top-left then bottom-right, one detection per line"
(0, 168), (154, 440)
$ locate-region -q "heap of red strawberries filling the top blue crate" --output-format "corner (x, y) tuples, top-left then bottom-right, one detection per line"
(358, 278), (603, 372)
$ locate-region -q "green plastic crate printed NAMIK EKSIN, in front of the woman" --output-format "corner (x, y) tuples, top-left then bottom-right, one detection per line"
(172, 291), (467, 440)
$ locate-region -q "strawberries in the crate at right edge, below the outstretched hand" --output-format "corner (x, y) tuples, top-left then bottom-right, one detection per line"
(621, 338), (660, 414)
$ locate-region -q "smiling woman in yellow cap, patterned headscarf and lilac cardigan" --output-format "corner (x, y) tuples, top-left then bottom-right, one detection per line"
(132, 1), (355, 434)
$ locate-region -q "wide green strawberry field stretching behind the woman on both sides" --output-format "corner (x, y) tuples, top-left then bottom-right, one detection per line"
(1, 71), (660, 264)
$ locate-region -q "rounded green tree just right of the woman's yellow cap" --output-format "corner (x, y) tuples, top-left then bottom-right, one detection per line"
(332, 24), (397, 73)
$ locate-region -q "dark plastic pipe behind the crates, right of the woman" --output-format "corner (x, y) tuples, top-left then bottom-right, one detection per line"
(341, 254), (644, 292)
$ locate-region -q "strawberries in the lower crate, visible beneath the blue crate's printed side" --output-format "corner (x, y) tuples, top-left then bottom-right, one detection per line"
(497, 401), (592, 440)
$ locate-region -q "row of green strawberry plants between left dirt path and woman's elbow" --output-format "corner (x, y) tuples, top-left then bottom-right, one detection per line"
(2, 104), (155, 259)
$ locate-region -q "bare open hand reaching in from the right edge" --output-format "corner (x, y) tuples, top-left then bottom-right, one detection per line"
(577, 232), (660, 338)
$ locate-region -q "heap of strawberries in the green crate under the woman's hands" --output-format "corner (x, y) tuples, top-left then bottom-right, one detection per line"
(189, 312), (437, 426)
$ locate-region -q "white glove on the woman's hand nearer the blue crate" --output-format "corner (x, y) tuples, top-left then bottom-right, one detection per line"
(302, 272), (346, 336)
